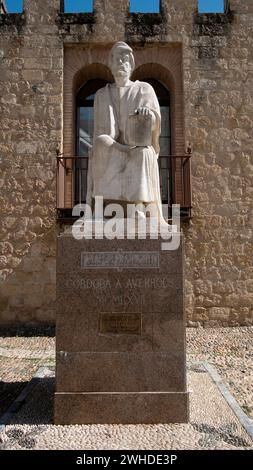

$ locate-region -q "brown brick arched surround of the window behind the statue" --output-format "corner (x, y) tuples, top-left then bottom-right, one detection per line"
(57, 46), (192, 218)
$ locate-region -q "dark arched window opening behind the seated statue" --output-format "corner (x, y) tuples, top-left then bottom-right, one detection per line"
(75, 78), (172, 204)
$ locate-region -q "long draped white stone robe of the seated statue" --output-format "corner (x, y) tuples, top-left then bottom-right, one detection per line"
(87, 80), (161, 212)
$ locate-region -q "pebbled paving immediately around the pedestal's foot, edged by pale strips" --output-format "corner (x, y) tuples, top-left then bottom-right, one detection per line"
(0, 364), (253, 450)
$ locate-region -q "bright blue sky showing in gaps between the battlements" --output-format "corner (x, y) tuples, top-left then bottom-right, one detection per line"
(5, 0), (224, 13)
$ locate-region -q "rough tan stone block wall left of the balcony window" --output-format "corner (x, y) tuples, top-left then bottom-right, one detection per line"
(0, 0), (63, 323)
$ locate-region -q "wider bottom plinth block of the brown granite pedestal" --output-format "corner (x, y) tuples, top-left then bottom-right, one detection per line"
(55, 392), (189, 424)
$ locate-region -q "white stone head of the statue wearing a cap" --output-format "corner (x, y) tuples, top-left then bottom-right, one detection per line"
(109, 41), (135, 77)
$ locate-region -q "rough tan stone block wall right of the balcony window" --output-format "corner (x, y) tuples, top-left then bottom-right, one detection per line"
(184, 0), (253, 326)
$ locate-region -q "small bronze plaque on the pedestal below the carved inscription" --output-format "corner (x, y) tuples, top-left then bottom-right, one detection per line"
(99, 313), (141, 335)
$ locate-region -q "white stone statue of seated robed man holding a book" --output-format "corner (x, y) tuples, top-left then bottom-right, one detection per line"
(87, 42), (161, 218)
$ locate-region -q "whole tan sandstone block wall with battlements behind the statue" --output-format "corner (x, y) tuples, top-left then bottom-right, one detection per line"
(0, 0), (253, 326)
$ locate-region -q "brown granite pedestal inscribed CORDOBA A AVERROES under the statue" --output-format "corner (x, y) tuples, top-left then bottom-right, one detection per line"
(55, 234), (188, 424)
